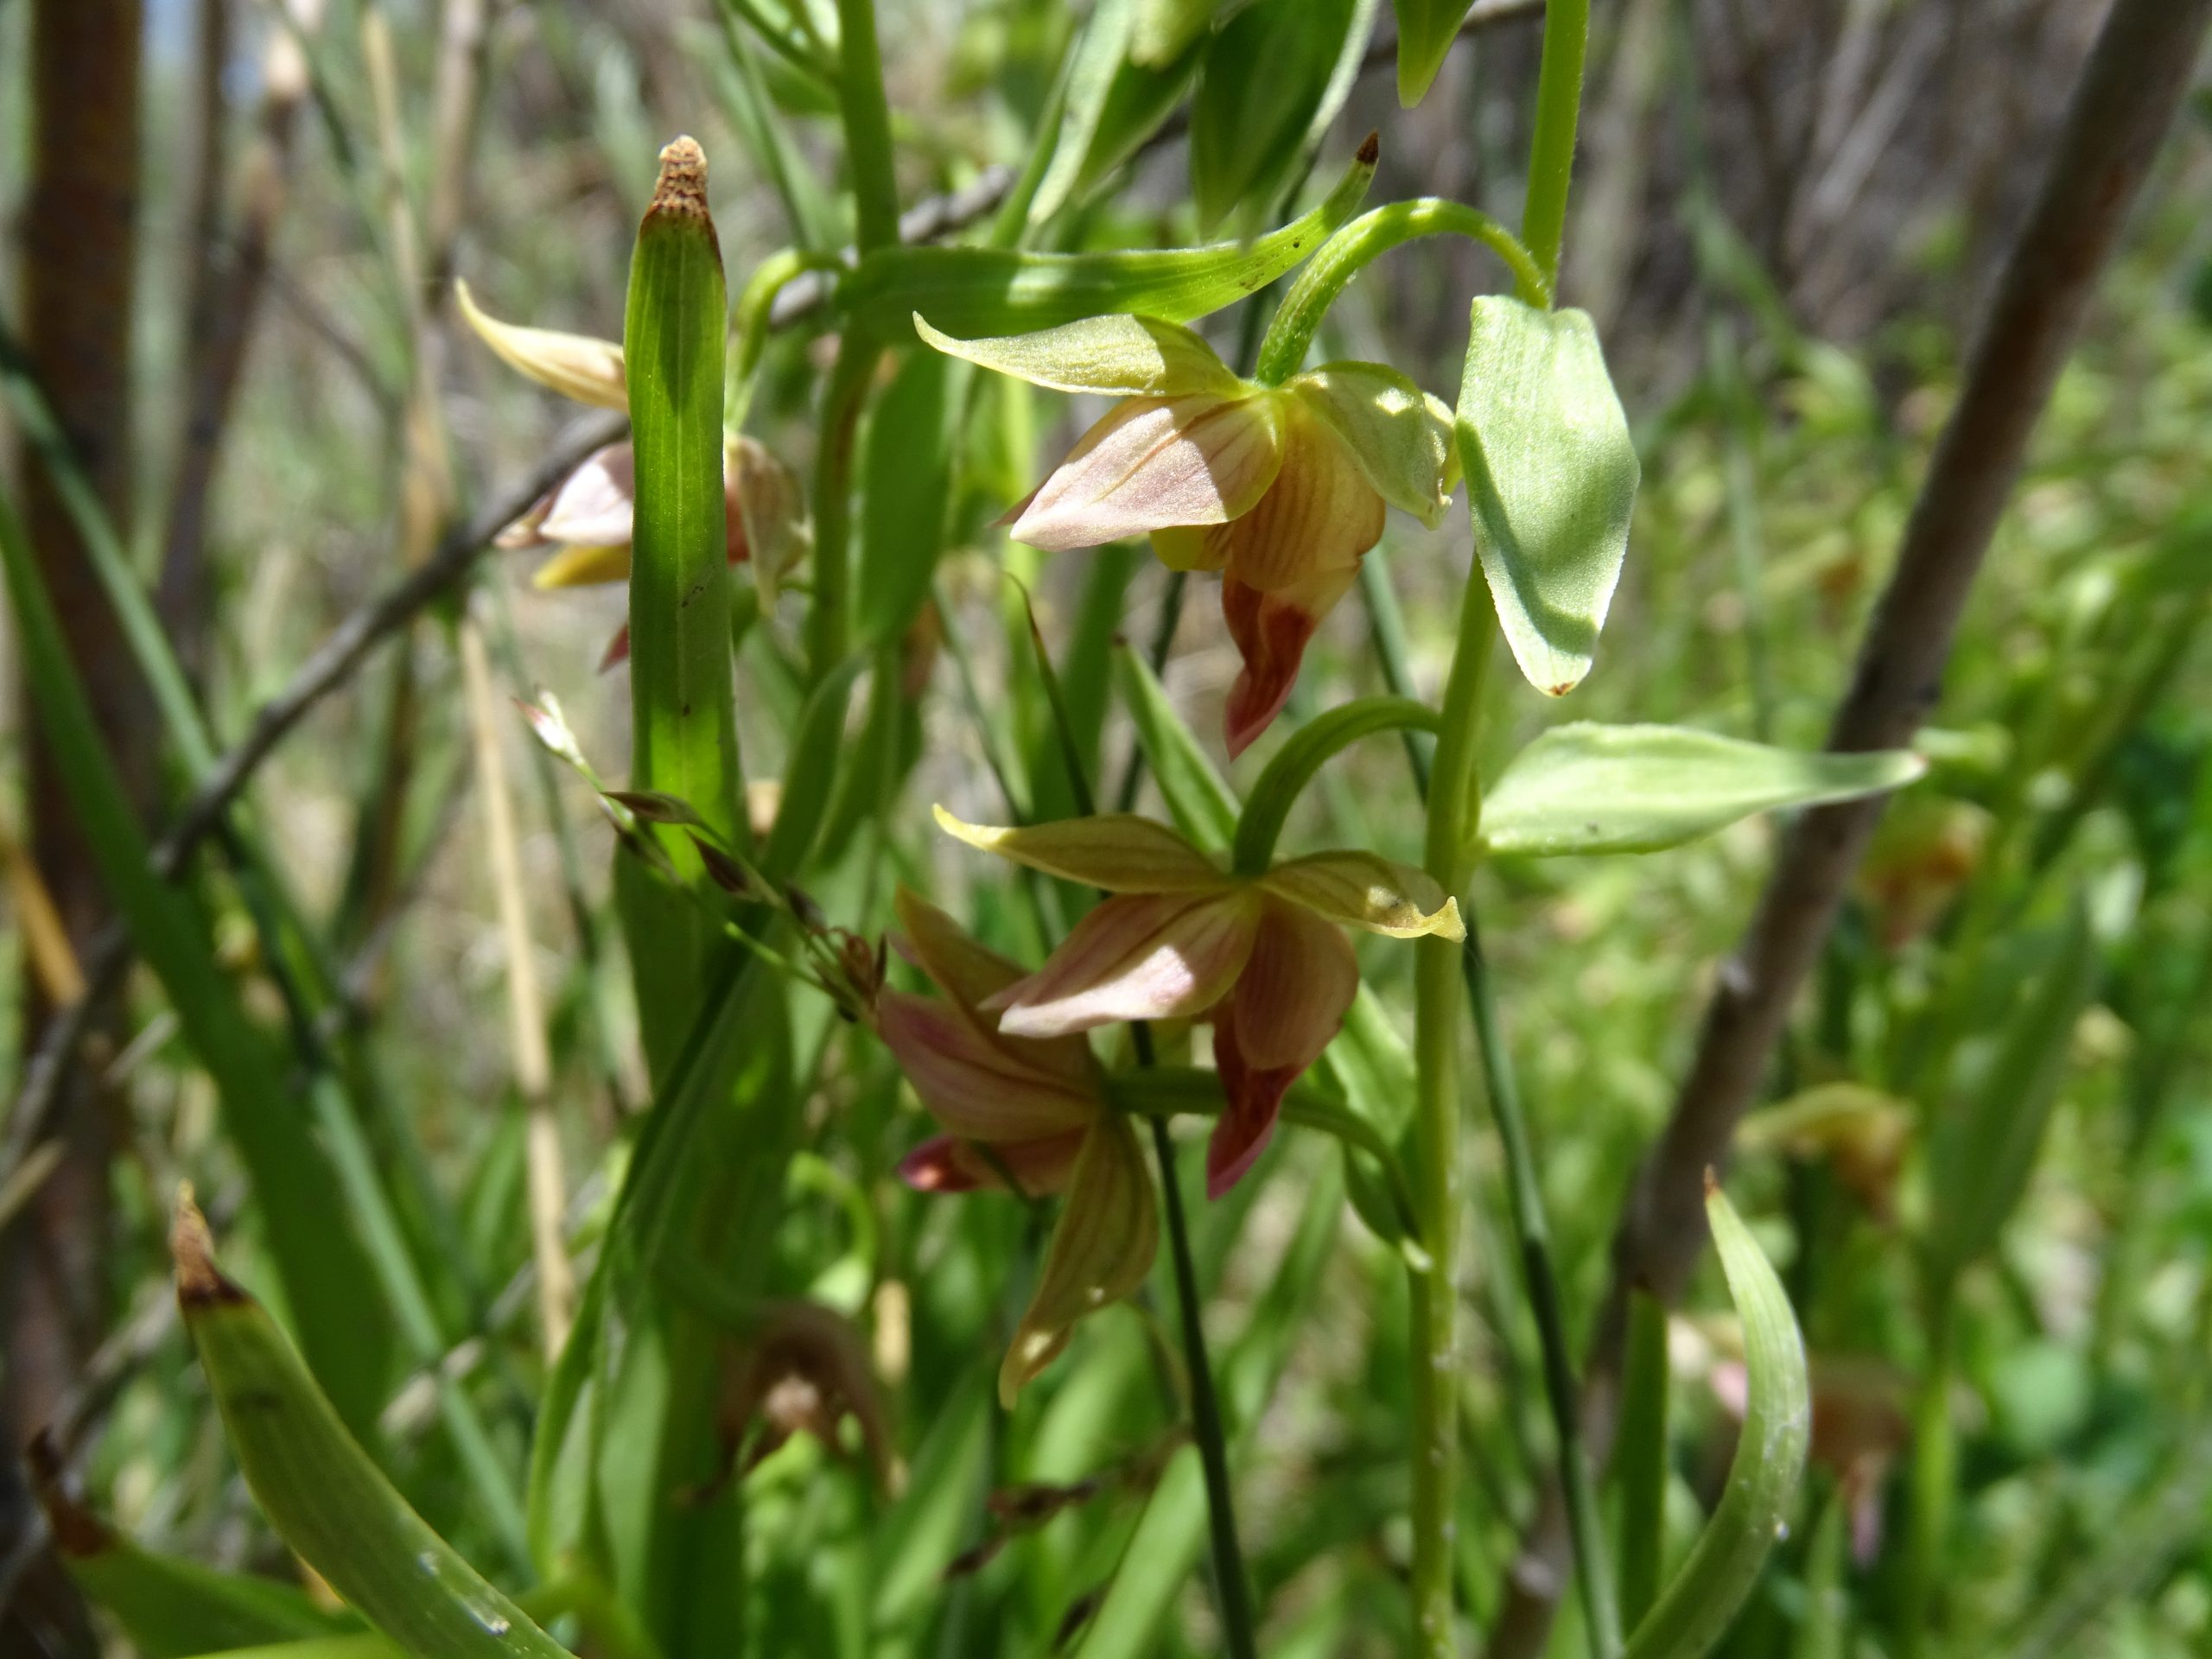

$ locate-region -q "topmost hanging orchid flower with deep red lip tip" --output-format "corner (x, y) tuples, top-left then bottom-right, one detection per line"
(913, 315), (1458, 754)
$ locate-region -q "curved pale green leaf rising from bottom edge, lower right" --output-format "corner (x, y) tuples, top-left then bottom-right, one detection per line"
(1624, 1177), (1812, 1659)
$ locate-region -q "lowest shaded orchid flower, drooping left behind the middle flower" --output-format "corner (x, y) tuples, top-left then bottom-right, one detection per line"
(876, 889), (1159, 1407)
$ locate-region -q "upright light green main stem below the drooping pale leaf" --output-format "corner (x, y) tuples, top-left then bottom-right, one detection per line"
(1411, 580), (1497, 1659)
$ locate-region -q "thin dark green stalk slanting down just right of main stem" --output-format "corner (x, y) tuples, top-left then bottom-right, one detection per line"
(1460, 925), (1628, 1659)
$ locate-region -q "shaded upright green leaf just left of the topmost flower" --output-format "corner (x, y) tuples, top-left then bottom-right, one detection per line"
(856, 349), (969, 646)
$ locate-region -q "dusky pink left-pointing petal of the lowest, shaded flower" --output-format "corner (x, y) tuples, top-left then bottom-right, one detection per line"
(876, 991), (1097, 1146)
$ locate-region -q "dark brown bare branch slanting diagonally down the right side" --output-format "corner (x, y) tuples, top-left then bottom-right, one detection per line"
(1491, 0), (2212, 1659)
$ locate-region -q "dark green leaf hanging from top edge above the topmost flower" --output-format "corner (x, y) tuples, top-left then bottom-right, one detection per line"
(1190, 0), (1360, 232)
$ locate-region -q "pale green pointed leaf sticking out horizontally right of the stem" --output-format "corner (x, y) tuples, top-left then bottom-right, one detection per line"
(1480, 721), (1927, 858)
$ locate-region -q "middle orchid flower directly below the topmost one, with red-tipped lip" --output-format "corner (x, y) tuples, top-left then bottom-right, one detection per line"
(938, 807), (1466, 1199)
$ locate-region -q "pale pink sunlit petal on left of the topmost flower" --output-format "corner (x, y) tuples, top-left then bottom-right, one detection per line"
(1013, 394), (1281, 550)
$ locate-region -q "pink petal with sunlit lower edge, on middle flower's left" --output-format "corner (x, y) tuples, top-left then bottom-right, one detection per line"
(982, 889), (1259, 1038)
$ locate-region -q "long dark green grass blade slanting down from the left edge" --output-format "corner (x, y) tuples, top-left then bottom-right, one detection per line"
(0, 498), (391, 1431)
